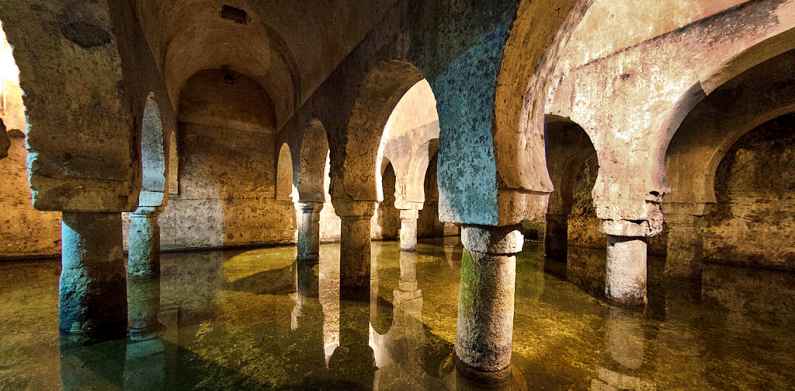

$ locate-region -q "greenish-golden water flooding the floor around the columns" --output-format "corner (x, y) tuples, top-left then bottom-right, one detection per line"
(0, 243), (795, 391)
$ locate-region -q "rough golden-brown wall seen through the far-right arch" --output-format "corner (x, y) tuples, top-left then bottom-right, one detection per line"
(704, 115), (795, 270)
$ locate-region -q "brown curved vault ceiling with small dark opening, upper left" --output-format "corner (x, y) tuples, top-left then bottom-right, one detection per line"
(133, 0), (404, 127)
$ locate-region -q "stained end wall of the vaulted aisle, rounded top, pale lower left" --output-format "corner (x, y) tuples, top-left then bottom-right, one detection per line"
(153, 71), (295, 248)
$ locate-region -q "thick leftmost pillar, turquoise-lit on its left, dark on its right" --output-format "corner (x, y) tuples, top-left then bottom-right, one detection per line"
(59, 212), (127, 340)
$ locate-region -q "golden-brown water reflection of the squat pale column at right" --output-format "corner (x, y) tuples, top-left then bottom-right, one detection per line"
(591, 307), (656, 390)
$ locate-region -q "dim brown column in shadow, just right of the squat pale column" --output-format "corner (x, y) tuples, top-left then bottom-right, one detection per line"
(663, 203), (706, 280)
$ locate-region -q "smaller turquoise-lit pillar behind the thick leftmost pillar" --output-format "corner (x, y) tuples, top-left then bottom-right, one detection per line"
(127, 206), (160, 278)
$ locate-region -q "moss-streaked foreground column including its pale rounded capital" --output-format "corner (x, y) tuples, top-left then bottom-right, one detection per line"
(455, 226), (524, 382)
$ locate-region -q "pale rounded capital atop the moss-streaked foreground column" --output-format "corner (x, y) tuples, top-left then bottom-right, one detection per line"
(461, 225), (524, 255)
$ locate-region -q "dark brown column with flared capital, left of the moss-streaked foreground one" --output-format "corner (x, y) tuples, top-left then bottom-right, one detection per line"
(334, 201), (375, 300)
